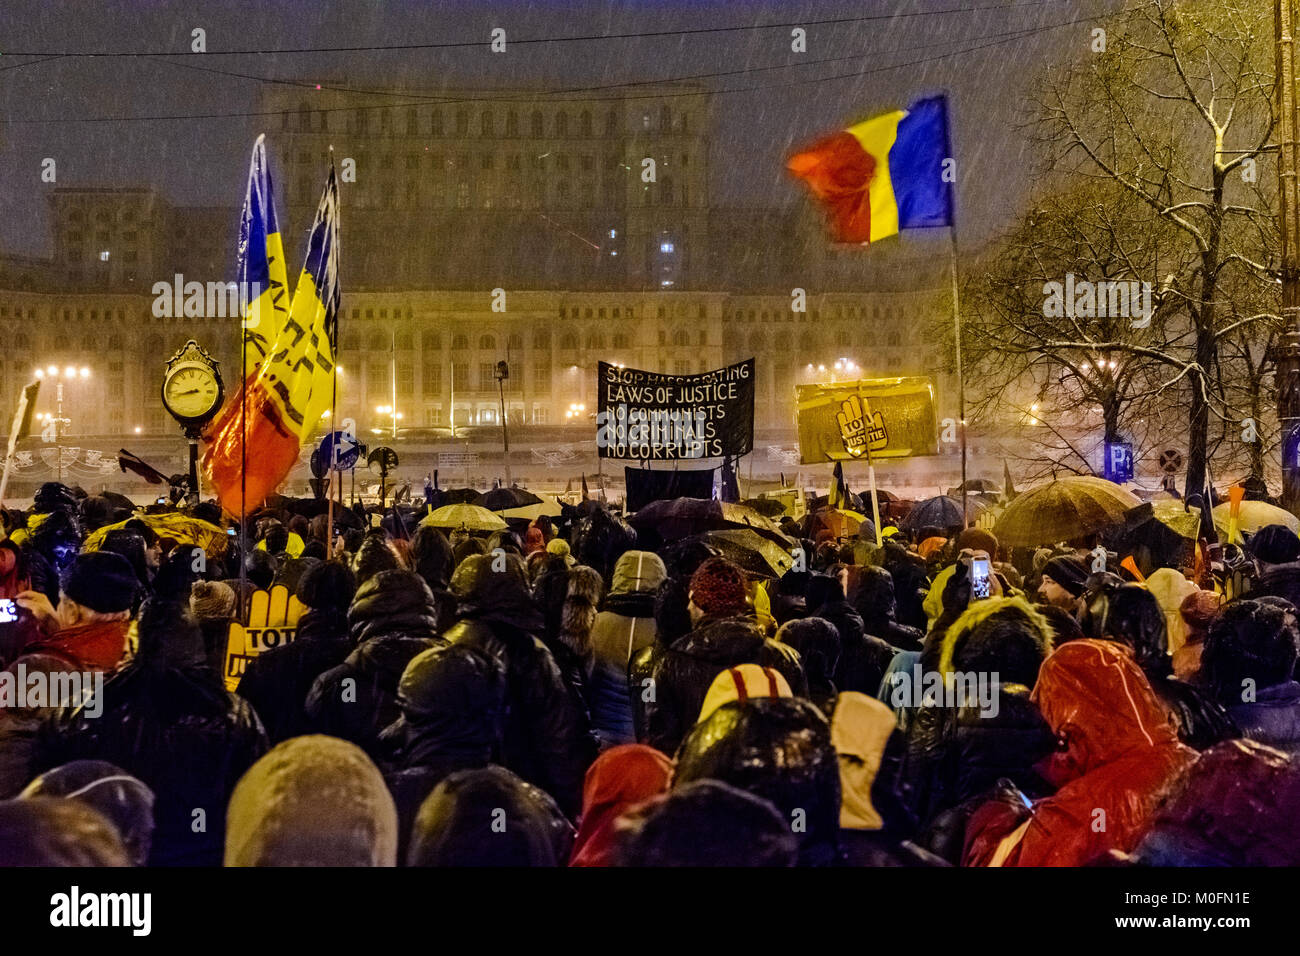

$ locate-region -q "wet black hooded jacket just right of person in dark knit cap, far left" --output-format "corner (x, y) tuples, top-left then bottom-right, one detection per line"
(35, 600), (267, 866)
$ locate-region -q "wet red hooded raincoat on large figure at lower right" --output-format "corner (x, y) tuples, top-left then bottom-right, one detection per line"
(962, 640), (1196, 866)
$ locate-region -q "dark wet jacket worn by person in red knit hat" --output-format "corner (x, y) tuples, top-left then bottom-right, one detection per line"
(646, 618), (807, 754)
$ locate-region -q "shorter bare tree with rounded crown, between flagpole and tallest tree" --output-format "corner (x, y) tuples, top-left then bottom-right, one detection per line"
(963, 183), (1180, 476)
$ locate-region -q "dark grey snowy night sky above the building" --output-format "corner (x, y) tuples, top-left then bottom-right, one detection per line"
(0, 0), (1114, 255)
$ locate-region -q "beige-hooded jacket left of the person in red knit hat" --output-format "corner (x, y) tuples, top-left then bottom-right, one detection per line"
(588, 551), (668, 747)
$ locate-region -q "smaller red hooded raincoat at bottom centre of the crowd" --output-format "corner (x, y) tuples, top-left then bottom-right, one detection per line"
(569, 744), (672, 866)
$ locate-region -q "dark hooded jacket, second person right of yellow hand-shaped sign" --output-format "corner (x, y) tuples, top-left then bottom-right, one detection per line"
(306, 570), (443, 756)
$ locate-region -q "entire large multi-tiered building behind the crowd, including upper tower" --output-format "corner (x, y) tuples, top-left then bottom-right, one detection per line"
(0, 87), (977, 494)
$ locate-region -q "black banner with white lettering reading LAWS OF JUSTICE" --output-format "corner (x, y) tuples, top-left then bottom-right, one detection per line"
(595, 359), (754, 462)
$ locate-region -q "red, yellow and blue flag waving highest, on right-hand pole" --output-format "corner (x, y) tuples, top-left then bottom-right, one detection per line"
(785, 96), (953, 243)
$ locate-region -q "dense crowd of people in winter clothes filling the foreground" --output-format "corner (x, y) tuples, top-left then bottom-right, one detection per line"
(0, 483), (1300, 866)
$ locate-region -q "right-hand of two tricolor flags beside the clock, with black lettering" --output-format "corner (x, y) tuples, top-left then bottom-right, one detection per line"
(203, 149), (341, 514)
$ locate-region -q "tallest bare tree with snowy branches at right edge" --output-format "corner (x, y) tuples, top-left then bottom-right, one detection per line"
(1035, 0), (1277, 502)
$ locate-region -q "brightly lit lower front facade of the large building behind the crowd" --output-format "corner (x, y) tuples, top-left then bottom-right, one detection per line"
(0, 282), (933, 436)
